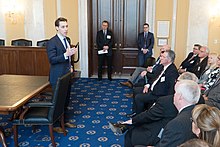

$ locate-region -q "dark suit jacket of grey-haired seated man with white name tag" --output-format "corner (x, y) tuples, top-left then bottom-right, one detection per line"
(150, 63), (179, 96)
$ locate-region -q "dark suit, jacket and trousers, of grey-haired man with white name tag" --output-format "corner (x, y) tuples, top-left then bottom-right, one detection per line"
(133, 63), (179, 114)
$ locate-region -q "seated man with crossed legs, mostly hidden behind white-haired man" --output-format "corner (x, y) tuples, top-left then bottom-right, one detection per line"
(109, 72), (198, 146)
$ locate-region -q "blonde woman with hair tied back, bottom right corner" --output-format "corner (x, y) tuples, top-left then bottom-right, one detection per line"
(192, 104), (220, 147)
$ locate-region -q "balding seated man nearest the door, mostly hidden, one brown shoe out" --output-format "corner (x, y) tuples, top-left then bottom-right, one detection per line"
(120, 45), (170, 88)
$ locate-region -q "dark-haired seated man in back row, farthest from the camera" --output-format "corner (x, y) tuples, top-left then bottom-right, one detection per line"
(178, 44), (201, 74)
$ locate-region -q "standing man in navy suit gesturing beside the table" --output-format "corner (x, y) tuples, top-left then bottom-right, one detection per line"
(46, 17), (77, 128)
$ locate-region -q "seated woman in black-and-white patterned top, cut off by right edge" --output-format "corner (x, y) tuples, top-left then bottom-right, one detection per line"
(200, 55), (220, 93)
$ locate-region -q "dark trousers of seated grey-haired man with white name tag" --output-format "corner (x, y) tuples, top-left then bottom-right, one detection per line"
(132, 87), (158, 114)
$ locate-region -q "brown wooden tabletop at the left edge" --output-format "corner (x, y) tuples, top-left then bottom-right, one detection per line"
(0, 75), (50, 114)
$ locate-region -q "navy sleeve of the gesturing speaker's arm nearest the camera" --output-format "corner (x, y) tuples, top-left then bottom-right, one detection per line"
(47, 40), (66, 64)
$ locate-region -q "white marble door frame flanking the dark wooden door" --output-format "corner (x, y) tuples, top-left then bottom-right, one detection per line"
(78, 0), (156, 78)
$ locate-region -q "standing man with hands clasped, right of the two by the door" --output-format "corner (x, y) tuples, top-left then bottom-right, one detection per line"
(138, 23), (154, 67)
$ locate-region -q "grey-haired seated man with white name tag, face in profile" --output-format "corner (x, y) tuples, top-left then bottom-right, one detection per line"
(128, 50), (179, 117)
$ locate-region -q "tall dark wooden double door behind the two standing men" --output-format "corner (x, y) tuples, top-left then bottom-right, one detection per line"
(88, 0), (146, 76)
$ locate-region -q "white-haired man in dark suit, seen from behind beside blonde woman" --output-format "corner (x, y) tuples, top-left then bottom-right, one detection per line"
(156, 80), (201, 147)
